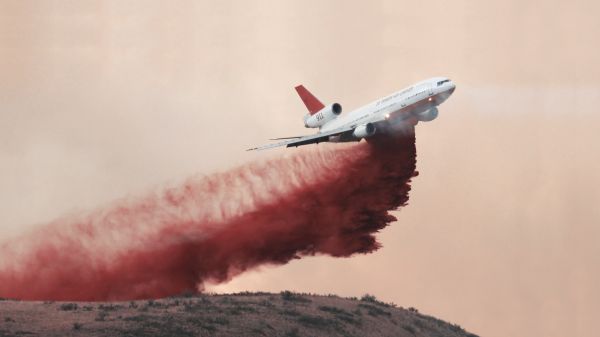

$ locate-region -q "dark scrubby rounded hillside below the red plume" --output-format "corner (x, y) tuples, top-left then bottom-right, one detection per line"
(0, 292), (476, 337)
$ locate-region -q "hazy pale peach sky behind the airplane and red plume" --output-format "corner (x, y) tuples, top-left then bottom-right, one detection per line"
(0, 0), (600, 337)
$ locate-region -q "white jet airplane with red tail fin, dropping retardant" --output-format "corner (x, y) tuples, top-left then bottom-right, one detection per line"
(247, 77), (456, 151)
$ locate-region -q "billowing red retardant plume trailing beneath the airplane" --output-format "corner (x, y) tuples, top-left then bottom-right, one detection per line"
(0, 130), (417, 301)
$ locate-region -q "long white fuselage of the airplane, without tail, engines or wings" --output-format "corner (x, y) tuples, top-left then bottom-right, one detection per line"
(319, 77), (456, 132)
